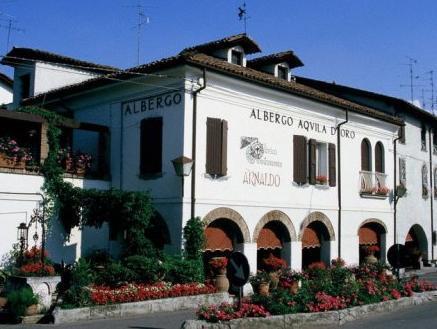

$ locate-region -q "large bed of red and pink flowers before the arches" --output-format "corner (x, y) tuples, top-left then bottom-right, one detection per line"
(197, 260), (437, 322)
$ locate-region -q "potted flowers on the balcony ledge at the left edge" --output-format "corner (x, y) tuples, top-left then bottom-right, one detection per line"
(0, 137), (32, 169)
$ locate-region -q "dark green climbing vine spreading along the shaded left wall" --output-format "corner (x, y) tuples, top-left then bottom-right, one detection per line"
(20, 107), (154, 255)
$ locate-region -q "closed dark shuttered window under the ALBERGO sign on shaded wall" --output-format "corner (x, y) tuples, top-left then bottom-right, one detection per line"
(140, 117), (162, 176)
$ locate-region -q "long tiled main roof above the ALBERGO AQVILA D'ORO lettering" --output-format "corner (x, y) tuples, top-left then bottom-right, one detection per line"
(22, 52), (403, 125)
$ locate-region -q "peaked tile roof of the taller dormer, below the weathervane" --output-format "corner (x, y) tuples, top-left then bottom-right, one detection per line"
(180, 33), (261, 54)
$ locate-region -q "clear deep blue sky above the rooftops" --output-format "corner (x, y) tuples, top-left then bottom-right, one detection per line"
(0, 0), (437, 109)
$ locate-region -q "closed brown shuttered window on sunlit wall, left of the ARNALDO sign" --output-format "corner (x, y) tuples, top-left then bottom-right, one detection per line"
(206, 118), (228, 176)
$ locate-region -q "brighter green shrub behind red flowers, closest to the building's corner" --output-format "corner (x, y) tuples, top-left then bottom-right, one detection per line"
(163, 256), (205, 283)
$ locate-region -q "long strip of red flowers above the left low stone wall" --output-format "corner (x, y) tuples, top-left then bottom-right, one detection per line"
(90, 282), (216, 305)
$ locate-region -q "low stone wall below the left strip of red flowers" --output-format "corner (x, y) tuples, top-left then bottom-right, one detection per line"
(52, 293), (232, 324)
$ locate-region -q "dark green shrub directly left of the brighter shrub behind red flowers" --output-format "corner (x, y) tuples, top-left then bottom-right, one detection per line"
(124, 255), (164, 283)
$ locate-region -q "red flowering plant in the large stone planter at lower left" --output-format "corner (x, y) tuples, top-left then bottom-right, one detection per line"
(17, 246), (56, 276)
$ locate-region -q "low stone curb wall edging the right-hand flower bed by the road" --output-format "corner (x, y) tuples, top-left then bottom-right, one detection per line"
(181, 291), (437, 329)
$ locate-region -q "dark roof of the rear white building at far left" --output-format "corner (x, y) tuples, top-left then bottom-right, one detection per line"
(0, 47), (119, 73)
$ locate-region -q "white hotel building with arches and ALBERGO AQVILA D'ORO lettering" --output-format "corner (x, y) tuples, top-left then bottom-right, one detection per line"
(0, 35), (437, 271)
